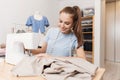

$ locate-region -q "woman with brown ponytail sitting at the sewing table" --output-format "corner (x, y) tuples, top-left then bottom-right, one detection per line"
(32, 6), (85, 59)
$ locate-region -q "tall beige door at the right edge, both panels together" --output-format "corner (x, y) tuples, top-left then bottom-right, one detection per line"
(106, 0), (120, 62)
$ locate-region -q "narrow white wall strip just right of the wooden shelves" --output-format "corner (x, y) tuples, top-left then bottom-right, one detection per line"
(94, 0), (101, 66)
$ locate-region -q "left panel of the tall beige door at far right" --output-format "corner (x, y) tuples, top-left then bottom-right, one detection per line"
(105, 2), (116, 62)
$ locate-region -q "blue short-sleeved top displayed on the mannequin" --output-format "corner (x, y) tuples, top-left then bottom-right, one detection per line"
(26, 16), (49, 33)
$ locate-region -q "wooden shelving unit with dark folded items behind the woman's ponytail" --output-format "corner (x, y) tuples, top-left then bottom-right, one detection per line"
(81, 16), (94, 63)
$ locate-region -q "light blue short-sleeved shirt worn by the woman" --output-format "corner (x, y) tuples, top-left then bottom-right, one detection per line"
(45, 28), (78, 56)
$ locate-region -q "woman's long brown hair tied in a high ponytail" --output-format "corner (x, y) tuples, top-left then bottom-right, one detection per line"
(60, 6), (83, 48)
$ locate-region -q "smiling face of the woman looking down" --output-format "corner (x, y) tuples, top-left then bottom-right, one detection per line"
(58, 12), (73, 34)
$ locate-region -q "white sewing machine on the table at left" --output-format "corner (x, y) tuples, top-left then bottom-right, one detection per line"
(5, 33), (43, 65)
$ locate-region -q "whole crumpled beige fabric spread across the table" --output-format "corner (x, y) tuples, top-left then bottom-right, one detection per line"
(11, 56), (97, 80)
